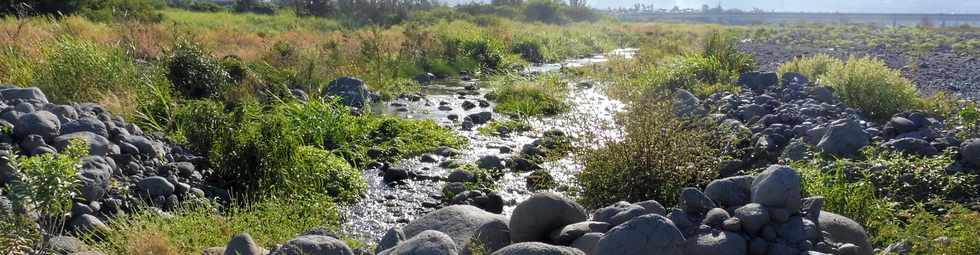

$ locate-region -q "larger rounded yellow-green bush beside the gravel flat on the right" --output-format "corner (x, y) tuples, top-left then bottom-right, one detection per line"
(819, 57), (920, 120)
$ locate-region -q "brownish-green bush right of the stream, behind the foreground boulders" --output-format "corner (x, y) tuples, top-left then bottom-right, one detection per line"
(577, 96), (732, 208)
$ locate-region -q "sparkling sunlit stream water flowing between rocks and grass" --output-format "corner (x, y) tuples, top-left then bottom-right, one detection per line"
(342, 49), (637, 243)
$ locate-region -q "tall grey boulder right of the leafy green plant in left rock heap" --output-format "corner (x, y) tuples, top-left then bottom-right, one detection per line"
(78, 156), (112, 202)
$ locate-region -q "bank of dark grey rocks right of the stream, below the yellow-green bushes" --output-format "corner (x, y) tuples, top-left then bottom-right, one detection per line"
(674, 72), (980, 176)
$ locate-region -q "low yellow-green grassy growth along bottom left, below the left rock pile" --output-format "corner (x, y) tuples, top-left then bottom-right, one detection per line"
(82, 197), (340, 254)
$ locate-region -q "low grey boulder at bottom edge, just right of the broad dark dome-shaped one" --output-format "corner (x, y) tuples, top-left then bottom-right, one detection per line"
(684, 231), (749, 255)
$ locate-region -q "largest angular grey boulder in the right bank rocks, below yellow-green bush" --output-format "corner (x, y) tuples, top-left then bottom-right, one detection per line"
(817, 119), (871, 157)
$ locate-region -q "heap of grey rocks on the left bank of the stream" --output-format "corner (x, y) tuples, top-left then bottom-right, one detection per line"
(0, 86), (207, 238)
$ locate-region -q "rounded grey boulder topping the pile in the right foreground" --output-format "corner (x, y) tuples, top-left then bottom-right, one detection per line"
(752, 165), (802, 212)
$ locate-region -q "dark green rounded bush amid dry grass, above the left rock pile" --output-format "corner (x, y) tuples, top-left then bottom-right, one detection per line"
(167, 42), (231, 98)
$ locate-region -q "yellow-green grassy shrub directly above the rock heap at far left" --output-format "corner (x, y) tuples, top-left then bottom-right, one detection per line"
(34, 37), (143, 114)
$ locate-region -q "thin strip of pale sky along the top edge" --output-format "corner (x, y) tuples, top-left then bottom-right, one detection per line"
(449, 0), (980, 13)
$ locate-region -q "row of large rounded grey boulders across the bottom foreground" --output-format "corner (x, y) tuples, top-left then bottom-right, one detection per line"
(215, 165), (872, 255)
